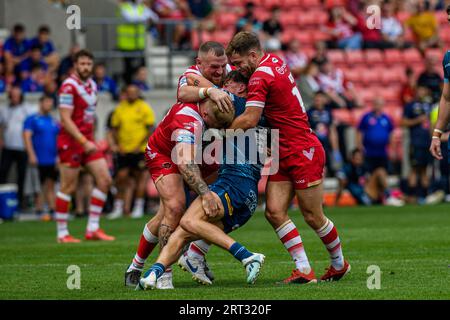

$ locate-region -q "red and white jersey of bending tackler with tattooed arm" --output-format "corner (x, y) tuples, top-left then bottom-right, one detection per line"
(146, 102), (205, 159)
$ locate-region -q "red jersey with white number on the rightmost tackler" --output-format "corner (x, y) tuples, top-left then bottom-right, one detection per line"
(246, 54), (320, 158)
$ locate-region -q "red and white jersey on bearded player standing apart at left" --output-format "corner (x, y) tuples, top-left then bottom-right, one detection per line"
(58, 74), (97, 140)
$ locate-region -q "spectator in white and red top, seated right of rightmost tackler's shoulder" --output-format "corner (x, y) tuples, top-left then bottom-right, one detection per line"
(318, 61), (361, 109)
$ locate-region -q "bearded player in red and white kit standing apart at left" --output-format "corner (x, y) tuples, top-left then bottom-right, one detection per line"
(55, 50), (114, 243)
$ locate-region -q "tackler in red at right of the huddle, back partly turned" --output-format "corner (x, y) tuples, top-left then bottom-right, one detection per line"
(226, 32), (350, 283)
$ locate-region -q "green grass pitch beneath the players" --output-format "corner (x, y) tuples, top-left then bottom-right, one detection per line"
(0, 205), (450, 300)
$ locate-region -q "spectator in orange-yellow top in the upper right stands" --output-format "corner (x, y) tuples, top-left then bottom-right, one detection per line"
(405, 0), (441, 52)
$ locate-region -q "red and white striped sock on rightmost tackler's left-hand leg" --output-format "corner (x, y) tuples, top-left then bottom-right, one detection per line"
(275, 220), (311, 274)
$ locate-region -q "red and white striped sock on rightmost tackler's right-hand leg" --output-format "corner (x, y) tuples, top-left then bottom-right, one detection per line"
(316, 219), (344, 270)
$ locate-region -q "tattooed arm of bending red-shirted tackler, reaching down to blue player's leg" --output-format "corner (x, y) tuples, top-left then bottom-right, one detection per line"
(176, 143), (221, 217)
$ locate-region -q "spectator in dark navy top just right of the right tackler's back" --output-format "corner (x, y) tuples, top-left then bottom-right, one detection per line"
(308, 91), (342, 176)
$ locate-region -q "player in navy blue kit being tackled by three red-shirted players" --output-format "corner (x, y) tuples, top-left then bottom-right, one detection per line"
(136, 71), (265, 290)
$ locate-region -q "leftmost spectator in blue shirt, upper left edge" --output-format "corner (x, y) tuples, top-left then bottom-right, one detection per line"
(3, 24), (30, 83)
